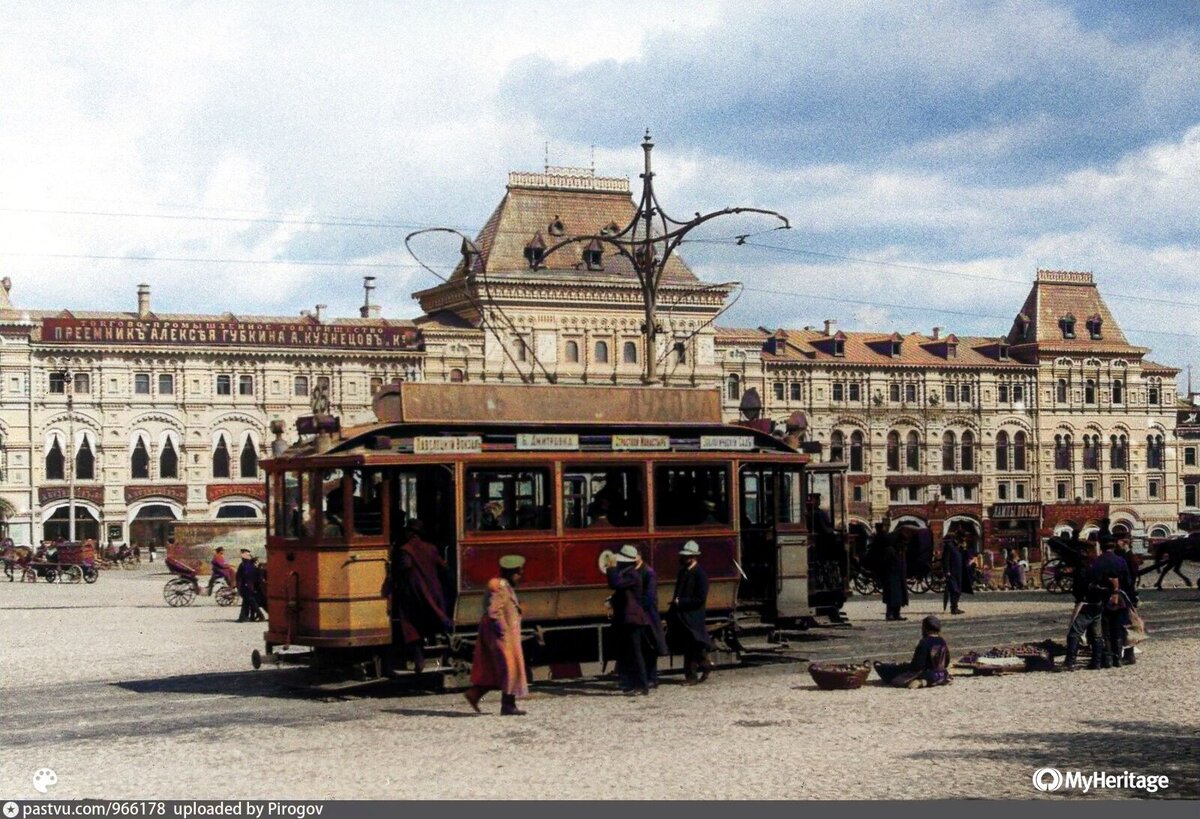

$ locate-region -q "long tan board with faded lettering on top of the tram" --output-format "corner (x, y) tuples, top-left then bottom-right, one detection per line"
(372, 382), (721, 426)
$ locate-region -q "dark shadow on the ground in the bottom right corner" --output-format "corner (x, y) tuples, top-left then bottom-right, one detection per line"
(920, 720), (1200, 799)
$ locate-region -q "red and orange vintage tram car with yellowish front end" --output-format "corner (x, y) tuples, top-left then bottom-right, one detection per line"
(256, 382), (848, 671)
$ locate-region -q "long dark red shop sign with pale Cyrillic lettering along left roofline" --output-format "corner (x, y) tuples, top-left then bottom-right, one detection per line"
(42, 316), (420, 349)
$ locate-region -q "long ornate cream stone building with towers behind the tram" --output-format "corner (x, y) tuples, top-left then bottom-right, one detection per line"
(0, 168), (1180, 549)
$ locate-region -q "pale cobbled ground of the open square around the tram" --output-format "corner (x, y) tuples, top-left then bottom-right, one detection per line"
(0, 567), (1200, 799)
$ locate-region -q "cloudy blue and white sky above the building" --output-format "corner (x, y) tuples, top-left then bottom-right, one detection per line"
(0, 0), (1200, 383)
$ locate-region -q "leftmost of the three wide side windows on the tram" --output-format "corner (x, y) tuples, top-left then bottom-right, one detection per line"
(467, 467), (552, 532)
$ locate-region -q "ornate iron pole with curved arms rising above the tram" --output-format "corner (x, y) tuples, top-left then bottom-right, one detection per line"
(536, 130), (791, 384)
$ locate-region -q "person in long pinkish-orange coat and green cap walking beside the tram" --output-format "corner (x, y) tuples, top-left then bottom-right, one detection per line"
(463, 555), (529, 716)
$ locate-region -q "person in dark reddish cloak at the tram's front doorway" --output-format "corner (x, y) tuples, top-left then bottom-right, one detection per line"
(391, 518), (451, 674)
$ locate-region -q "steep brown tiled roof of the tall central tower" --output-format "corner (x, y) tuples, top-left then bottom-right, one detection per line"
(451, 176), (698, 283)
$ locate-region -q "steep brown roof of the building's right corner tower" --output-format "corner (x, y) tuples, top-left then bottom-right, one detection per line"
(1008, 270), (1147, 355)
